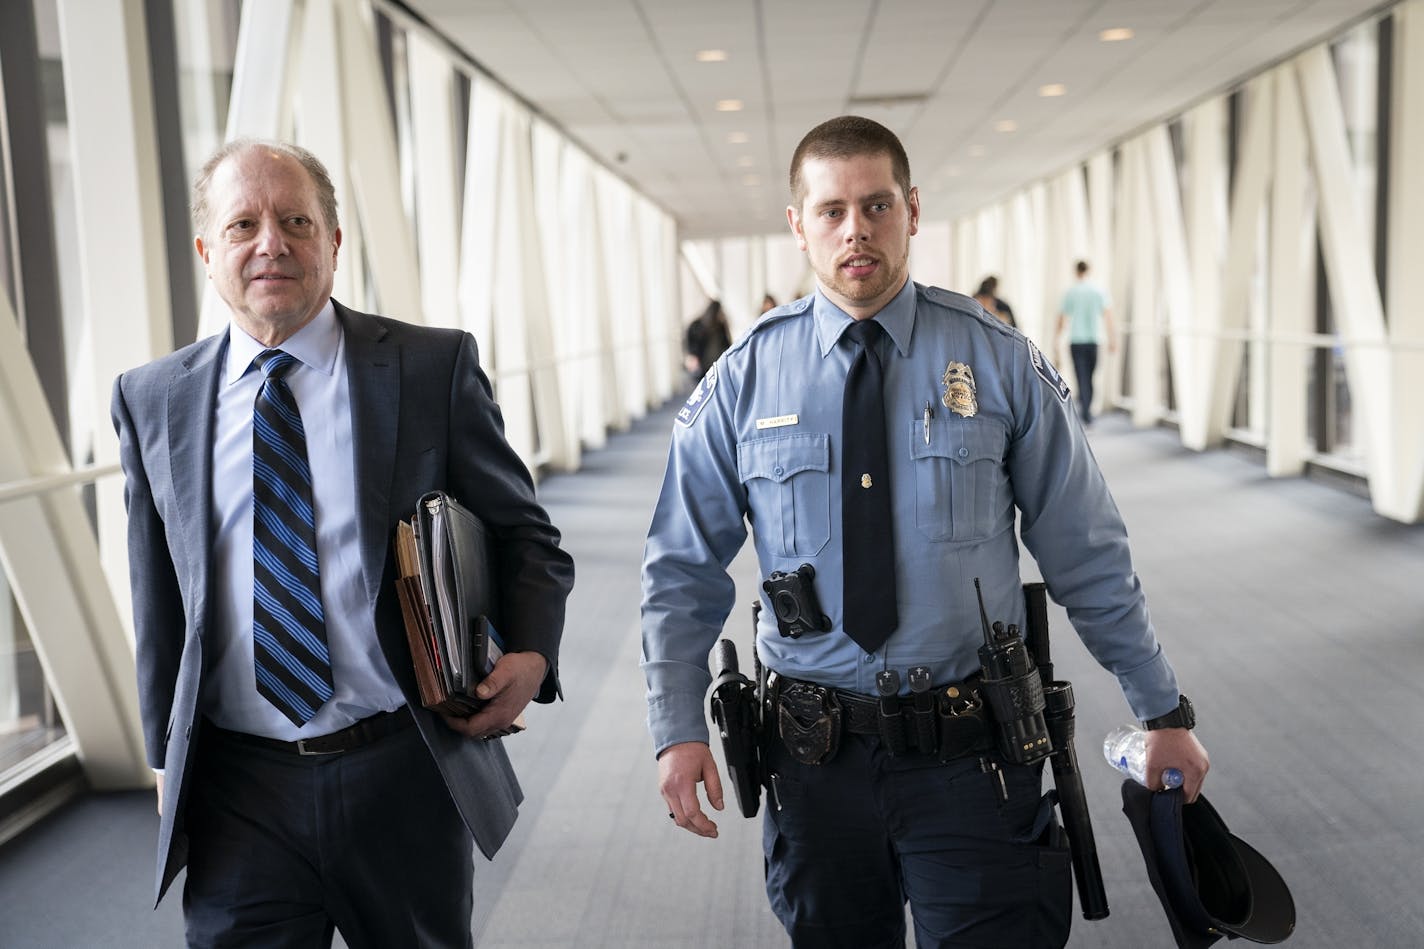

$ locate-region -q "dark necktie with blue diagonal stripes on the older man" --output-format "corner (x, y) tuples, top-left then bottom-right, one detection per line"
(252, 349), (332, 725)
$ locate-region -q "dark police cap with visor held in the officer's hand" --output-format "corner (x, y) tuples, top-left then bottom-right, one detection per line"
(1122, 781), (1296, 949)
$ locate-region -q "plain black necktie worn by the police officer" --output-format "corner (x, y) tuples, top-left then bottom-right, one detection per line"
(840, 319), (900, 653)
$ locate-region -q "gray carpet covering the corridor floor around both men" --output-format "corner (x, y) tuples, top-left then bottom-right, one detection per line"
(0, 412), (1424, 949)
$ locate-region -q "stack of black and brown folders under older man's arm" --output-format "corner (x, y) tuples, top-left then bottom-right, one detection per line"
(396, 492), (504, 718)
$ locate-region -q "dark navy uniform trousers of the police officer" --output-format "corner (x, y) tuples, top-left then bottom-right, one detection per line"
(762, 734), (1072, 949)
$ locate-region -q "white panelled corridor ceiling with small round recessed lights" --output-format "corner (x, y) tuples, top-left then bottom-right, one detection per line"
(406, 0), (1391, 237)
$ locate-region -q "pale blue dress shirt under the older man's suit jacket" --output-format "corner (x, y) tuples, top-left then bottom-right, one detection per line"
(202, 301), (406, 741)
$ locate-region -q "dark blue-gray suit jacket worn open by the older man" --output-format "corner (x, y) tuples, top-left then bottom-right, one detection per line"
(111, 301), (574, 899)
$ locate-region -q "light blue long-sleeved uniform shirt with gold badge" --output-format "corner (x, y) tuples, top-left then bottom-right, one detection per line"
(642, 281), (1178, 754)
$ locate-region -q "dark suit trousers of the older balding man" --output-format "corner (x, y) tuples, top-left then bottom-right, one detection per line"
(184, 712), (474, 949)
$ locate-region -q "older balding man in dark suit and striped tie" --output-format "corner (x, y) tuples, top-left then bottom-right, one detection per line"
(112, 141), (574, 948)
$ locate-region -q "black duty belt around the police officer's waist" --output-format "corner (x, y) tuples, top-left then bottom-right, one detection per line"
(773, 675), (994, 761)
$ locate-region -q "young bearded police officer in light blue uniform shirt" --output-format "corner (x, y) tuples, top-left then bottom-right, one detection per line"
(642, 117), (1208, 949)
